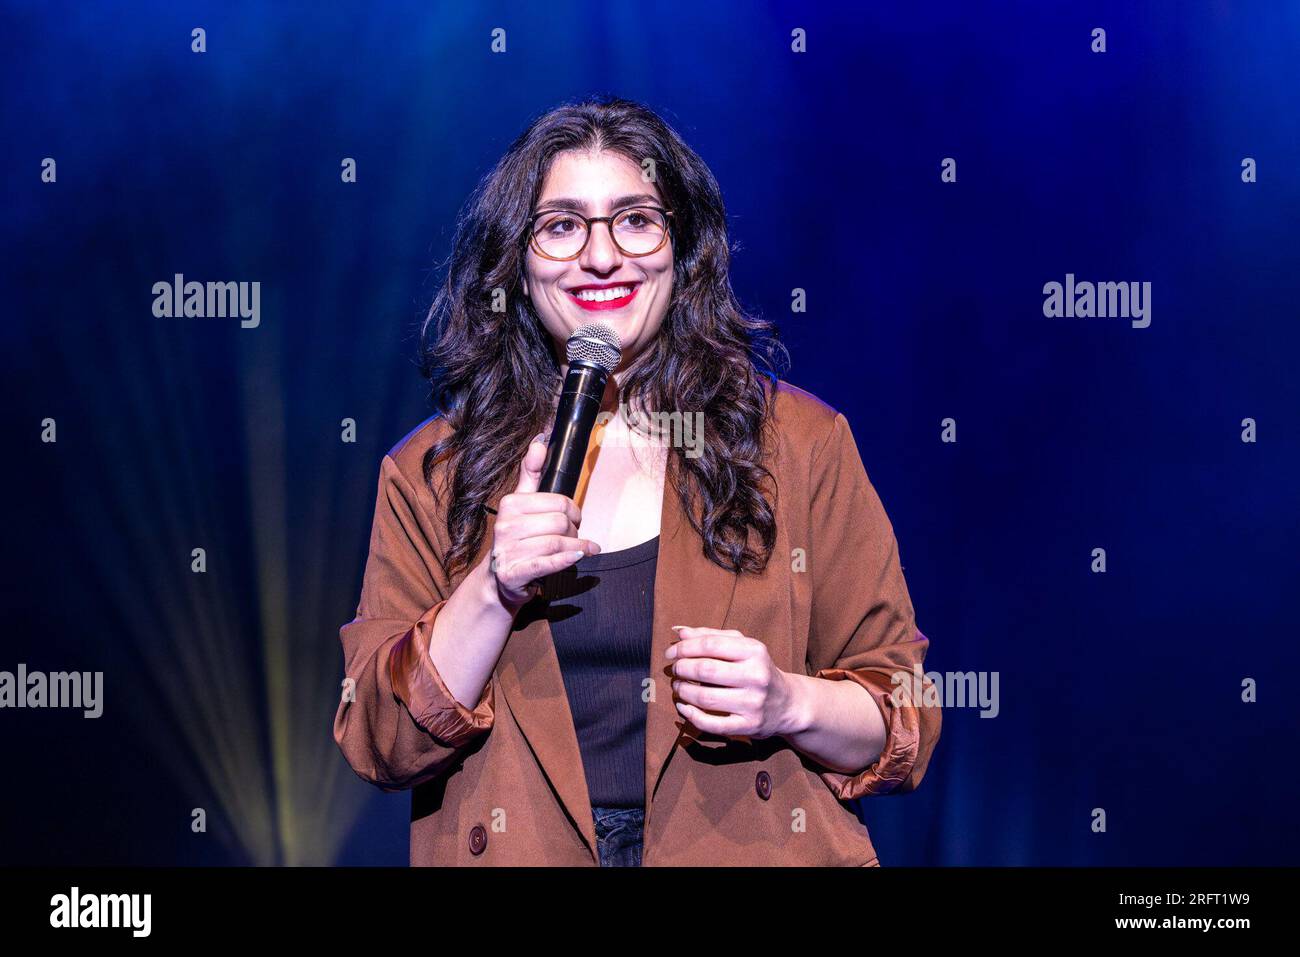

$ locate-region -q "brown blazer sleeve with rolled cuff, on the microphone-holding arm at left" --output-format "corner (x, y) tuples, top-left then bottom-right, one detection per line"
(334, 455), (495, 791)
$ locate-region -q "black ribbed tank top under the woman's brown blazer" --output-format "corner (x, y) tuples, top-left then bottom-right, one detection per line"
(542, 536), (659, 807)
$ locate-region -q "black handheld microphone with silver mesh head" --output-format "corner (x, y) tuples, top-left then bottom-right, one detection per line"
(537, 322), (623, 498)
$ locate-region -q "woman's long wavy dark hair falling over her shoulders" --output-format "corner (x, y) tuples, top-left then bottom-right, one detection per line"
(420, 96), (788, 573)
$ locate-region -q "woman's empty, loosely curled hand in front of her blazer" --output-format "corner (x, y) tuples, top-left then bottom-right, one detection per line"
(667, 625), (798, 739)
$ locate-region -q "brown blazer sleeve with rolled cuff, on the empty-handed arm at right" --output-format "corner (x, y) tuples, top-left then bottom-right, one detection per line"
(809, 413), (943, 801)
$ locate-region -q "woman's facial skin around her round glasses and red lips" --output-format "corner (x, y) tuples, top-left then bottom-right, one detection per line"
(524, 151), (672, 369)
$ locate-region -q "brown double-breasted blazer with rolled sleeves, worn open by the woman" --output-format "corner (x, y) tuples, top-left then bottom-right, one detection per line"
(334, 382), (941, 866)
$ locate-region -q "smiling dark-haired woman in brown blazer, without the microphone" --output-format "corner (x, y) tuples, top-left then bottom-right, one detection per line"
(334, 99), (940, 866)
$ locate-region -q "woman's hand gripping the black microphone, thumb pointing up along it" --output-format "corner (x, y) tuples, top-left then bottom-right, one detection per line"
(488, 436), (601, 611)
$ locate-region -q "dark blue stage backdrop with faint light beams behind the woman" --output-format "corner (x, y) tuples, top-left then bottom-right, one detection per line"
(0, 1), (1300, 866)
